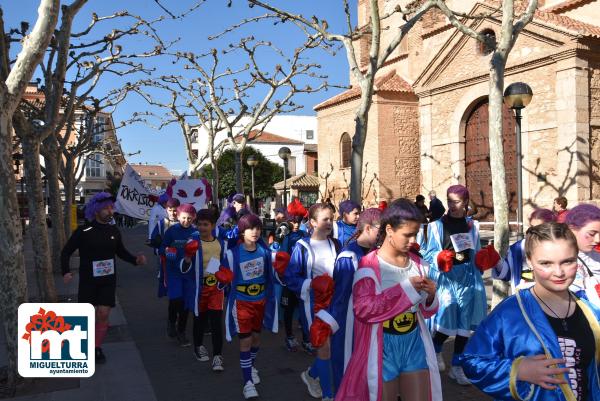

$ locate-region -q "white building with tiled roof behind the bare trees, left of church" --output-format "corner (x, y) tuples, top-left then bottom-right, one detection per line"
(192, 115), (318, 175)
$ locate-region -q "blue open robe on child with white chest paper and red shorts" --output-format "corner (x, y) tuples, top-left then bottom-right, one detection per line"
(222, 242), (279, 341)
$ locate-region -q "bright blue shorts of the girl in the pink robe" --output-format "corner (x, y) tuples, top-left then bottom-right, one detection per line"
(383, 327), (429, 382)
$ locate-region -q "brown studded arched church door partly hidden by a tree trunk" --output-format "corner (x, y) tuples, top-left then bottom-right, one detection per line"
(465, 98), (517, 221)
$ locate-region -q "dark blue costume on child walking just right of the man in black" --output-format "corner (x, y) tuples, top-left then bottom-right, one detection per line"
(159, 223), (200, 310)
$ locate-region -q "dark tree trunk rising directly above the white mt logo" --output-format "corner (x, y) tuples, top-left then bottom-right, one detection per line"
(21, 133), (58, 302)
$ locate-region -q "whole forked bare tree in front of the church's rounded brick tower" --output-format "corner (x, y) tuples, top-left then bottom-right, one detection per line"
(248, 0), (439, 203)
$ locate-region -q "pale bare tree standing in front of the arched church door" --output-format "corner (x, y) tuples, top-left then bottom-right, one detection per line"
(438, 0), (538, 305)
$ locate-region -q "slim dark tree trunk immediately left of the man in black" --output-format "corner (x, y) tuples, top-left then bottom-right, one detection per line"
(43, 135), (65, 273)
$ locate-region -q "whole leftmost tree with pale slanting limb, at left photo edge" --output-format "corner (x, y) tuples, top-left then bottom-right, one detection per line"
(0, 0), (60, 393)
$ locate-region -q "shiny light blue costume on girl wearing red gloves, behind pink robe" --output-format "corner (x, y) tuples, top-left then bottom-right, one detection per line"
(424, 218), (487, 337)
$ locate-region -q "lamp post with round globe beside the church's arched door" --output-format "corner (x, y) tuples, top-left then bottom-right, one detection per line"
(504, 82), (533, 239)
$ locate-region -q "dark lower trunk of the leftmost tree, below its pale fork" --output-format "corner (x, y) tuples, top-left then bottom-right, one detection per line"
(0, 112), (27, 396)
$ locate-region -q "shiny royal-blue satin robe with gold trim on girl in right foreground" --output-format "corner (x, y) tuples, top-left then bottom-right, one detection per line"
(460, 289), (600, 401)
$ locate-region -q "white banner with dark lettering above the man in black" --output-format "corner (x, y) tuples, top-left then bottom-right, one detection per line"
(115, 164), (164, 220)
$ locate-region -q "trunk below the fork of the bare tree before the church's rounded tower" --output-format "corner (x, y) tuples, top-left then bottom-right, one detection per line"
(350, 94), (373, 205)
